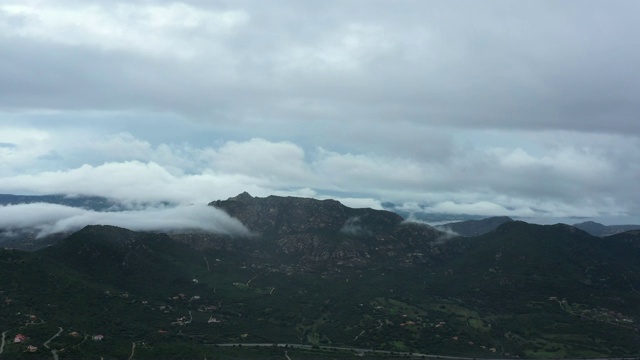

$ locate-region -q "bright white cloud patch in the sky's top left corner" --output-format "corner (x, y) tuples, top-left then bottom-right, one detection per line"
(0, 2), (249, 58)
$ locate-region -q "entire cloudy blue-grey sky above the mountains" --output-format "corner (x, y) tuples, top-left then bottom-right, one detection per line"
(0, 0), (640, 232)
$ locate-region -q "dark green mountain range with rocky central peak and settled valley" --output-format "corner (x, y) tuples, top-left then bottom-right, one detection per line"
(0, 193), (640, 359)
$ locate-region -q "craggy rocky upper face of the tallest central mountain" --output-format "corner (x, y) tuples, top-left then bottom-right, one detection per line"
(209, 192), (443, 270)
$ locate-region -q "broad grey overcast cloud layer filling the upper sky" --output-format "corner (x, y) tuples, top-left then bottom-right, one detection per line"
(0, 1), (640, 133)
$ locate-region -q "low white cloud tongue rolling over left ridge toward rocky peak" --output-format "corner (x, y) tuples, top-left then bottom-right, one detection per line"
(0, 203), (251, 237)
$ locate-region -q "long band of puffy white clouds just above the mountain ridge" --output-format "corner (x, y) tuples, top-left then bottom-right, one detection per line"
(0, 132), (640, 222)
